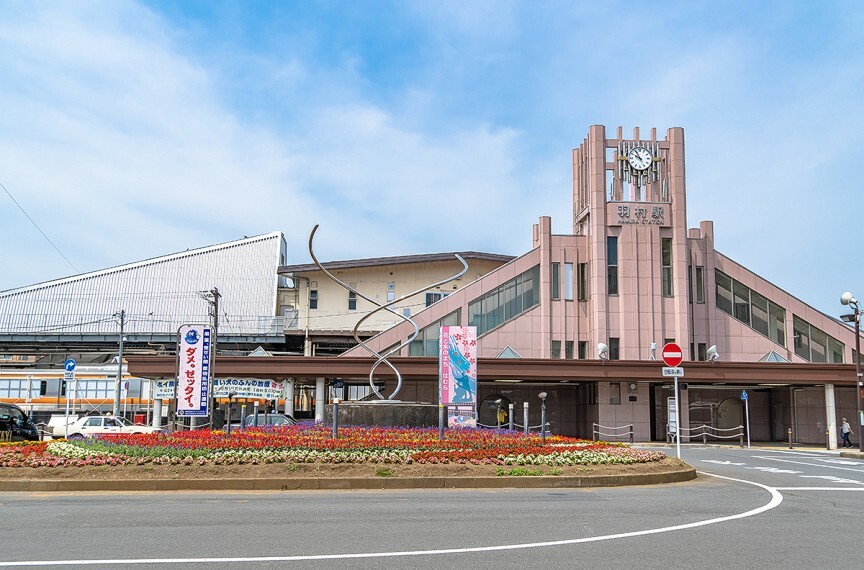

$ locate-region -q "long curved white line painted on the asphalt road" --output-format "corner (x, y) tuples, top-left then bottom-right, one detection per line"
(0, 471), (783, 568)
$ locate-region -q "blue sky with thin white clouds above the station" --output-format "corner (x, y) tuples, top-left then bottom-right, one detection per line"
(0, 0), (864, 315)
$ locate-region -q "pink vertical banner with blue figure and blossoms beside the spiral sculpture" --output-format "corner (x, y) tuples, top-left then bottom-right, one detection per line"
(438, 326), (477, 427)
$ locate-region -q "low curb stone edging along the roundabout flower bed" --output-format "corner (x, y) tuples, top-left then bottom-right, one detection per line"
(0, 465), (696, 492)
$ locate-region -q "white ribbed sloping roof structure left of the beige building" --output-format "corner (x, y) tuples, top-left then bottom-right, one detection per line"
(0, 232), (285, 334)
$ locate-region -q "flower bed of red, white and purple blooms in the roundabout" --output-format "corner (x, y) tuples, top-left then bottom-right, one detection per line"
(0, 425), (666, 467)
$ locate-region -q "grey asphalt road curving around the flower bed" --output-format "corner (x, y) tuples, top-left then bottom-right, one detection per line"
(0, 448), (864, 570)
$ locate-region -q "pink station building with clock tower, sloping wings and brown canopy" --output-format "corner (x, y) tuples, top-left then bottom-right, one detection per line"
(346, 125), (858, 446)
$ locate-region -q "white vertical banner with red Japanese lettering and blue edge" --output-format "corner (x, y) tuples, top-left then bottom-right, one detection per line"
(176, 325), (213, 416)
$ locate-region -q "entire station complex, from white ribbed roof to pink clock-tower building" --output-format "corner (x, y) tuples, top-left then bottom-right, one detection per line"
(0, 125), (858, 447)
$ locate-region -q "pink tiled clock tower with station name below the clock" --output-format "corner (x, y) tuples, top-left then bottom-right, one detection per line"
(573, 125), (691, 359)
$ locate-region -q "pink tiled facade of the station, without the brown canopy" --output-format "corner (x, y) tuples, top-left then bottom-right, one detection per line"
(355, 125), (854, 441)
